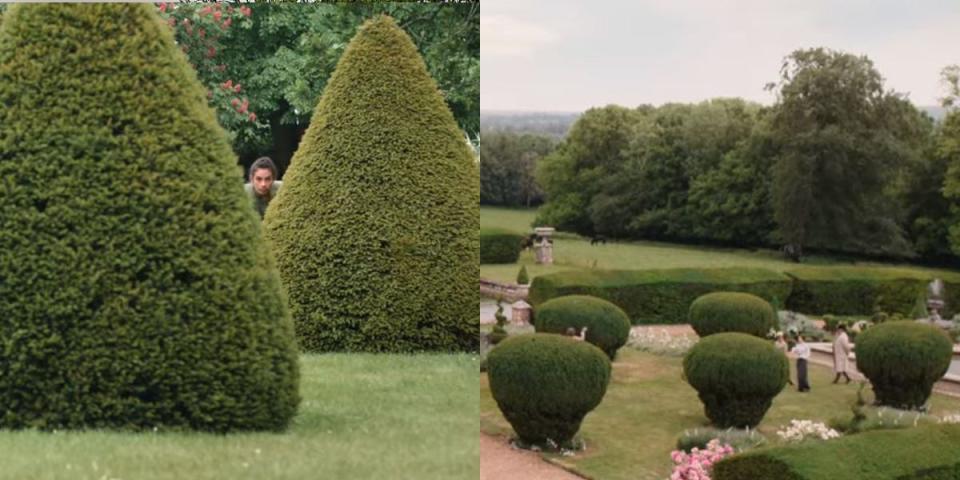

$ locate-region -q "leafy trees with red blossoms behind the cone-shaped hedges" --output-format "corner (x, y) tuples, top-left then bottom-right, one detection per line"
(158, 2), (488, 173)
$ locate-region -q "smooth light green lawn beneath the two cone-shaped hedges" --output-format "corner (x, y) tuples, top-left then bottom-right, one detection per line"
(0, 354), (480, 480)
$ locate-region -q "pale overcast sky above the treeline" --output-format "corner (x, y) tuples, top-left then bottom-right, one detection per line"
(480, 0), (960, 112)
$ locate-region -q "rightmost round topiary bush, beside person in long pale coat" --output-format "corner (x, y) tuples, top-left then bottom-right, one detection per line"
(856, 321), (953, 409)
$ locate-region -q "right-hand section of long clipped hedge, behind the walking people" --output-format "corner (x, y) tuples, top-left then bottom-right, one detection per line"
(784, 266), (960, 315)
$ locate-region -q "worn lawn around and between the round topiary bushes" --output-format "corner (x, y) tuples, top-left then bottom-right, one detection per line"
(480, 348), (960, 480)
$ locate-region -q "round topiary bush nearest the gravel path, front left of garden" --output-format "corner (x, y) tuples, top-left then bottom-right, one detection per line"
(487, 333), (610, 445)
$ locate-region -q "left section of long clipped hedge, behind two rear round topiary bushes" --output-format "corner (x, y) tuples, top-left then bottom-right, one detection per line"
(529, 268), (791, 325)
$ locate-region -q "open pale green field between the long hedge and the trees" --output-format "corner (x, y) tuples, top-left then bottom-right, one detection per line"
(480, 207), (960, 282)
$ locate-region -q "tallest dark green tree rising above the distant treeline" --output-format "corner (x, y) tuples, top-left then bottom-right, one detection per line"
(770, 48), (916, 255)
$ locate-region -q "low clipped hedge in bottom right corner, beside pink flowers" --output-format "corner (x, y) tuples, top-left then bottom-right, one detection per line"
(713, 425), (960, 480)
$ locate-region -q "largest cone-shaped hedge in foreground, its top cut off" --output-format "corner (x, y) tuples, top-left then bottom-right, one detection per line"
(0, 4), (299, 432)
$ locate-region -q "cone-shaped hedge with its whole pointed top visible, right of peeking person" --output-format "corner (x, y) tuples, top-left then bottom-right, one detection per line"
(264, 16), (480, 351)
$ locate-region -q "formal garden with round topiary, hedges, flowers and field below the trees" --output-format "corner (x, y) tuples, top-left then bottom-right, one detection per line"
(480, 207), (960, 479)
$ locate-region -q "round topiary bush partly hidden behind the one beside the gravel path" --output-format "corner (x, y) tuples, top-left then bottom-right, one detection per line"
(534, 295), (630, 360)
